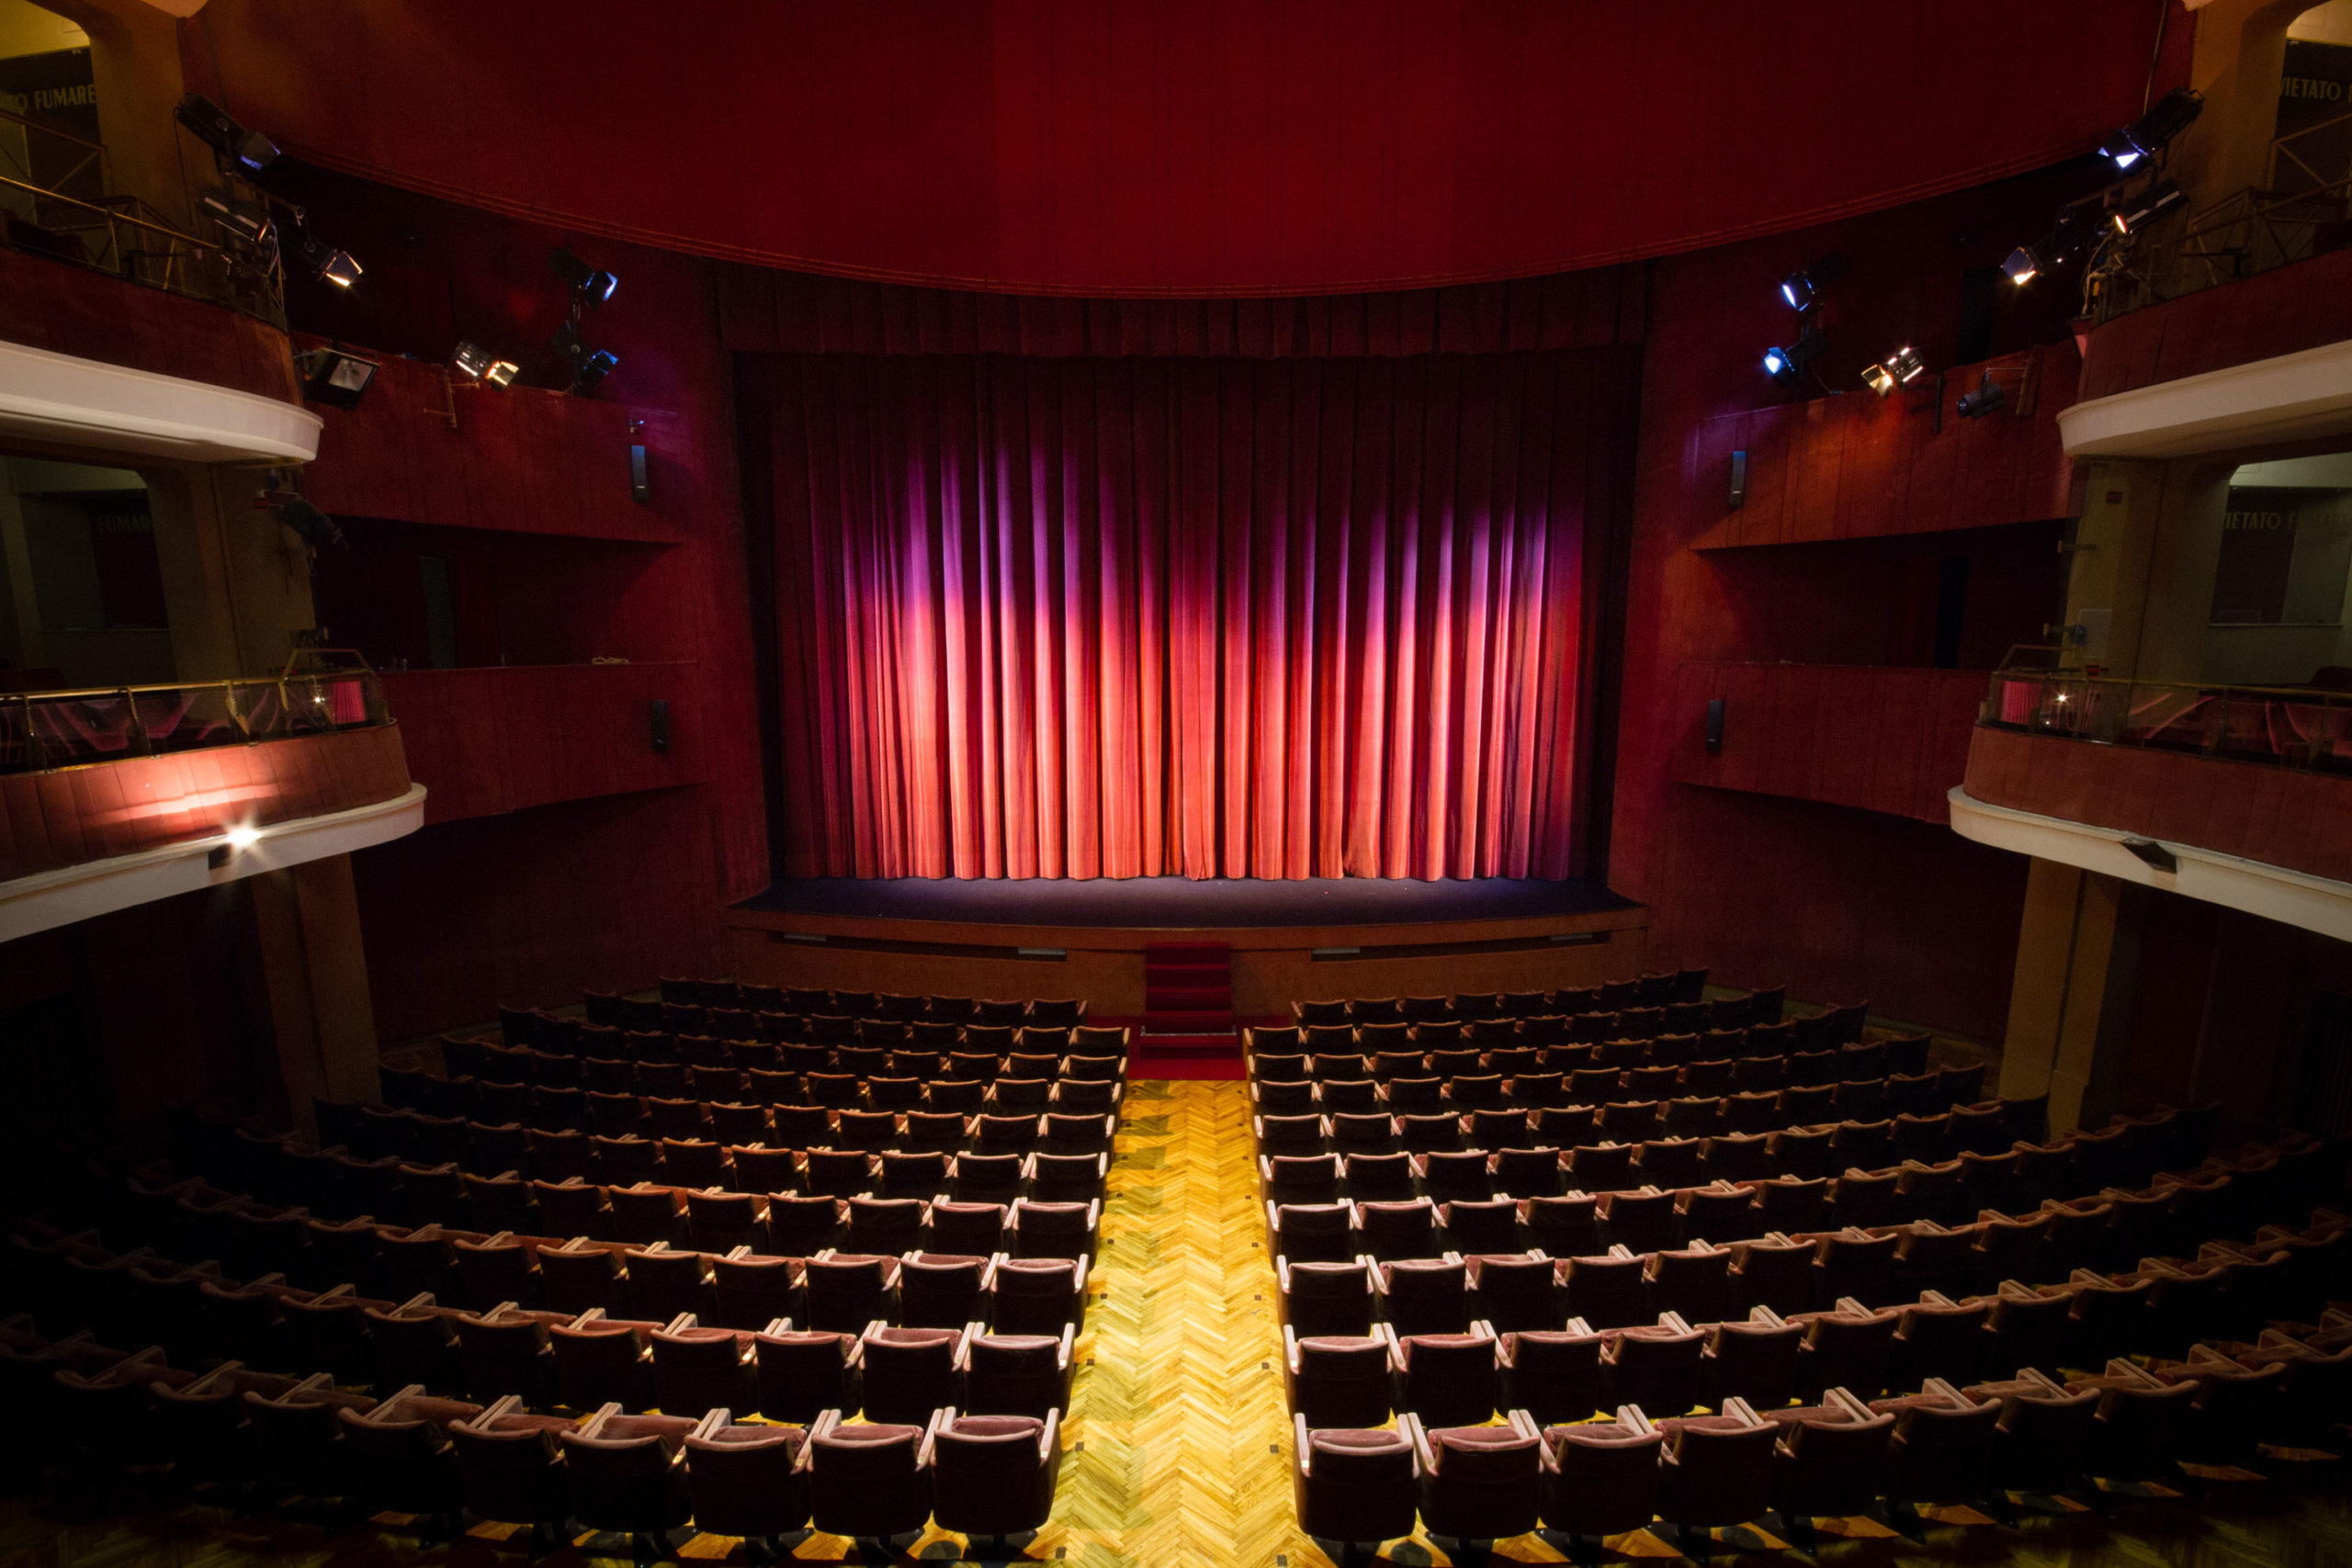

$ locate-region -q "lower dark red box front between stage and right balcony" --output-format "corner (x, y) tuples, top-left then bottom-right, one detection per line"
(1675, 660), (1985, 823)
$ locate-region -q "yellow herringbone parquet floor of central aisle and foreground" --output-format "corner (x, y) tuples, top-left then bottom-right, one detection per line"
(0, 1081), (2352, 1568)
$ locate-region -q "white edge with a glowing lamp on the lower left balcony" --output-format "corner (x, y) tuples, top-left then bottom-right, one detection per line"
(0, 783), (425, 942)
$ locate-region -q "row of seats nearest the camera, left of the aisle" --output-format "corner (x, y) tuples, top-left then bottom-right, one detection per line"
(0, 1319), (1061, 1561)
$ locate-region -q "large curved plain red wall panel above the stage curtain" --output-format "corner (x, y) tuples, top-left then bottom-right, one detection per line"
(181, 0), (2192, 297)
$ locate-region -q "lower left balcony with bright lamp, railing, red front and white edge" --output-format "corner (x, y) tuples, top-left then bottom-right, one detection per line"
(0, 672), (424, 941)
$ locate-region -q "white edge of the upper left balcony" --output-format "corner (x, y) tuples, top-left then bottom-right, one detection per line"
(0, 341), (324, 463)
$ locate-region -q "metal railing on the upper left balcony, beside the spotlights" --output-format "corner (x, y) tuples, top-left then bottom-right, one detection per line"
(0, 110), (287, 327)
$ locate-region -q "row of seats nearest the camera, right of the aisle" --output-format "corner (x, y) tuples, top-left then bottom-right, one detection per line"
(1291, 1314), (2352, 1556)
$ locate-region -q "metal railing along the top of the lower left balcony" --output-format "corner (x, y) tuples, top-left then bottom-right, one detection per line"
(0, 670), (390, 773)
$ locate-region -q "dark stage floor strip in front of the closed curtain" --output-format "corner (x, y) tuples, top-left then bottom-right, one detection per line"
(734, 877), (1634, 929)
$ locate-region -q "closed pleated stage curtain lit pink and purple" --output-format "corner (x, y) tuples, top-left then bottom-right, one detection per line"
(755, 350), (1633, 877)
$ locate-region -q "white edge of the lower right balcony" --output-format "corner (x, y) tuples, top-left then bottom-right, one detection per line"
(1948, 785), (2352, 942)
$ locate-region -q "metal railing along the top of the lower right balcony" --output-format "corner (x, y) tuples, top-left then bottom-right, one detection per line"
(1978, 670), (2352, 773)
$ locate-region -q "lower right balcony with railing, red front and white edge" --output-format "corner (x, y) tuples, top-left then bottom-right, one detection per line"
(1950, 670), (2352, 938)
